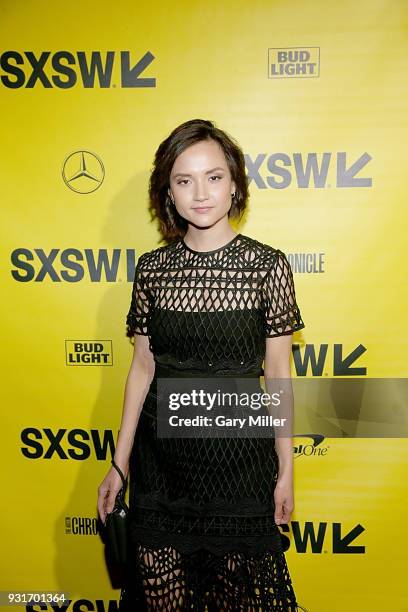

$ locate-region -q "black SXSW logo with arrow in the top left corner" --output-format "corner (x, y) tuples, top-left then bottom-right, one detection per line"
(0, 51), (156, 89)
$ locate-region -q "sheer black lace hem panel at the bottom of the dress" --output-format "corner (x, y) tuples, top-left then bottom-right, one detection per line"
(119, 543), (299, 612)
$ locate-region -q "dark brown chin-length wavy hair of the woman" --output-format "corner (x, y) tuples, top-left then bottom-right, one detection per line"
(149, 119), (249, 242)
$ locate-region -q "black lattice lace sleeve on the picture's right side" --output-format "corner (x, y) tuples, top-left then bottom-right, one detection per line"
(263, 249), (305, 338)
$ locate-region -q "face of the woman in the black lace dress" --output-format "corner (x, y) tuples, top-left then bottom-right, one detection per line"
(169, 140), (235, 228)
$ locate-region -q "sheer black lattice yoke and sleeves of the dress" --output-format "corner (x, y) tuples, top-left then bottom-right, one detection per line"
(127, 234), (304, 337)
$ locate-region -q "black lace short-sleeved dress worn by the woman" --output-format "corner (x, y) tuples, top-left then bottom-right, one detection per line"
(120, 234), (304, 612)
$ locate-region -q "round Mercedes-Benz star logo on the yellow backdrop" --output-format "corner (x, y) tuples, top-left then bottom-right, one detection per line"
(62, 150), (105, 193)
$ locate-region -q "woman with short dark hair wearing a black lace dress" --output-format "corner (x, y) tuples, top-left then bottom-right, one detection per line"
(98, 119), (304, 612)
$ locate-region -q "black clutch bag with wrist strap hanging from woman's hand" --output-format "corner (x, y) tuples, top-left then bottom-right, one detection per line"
(105, 460), (129, 565)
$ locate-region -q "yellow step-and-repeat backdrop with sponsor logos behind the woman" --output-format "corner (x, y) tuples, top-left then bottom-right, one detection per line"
(0, 0), (408, 612)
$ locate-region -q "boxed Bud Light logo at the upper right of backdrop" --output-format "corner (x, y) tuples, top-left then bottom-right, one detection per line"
(268, 47), (320, 79)
